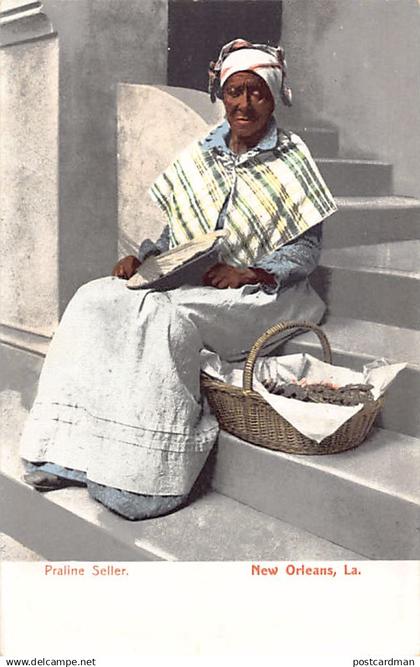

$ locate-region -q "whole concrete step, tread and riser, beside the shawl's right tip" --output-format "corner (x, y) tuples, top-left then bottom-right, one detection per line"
(322, 197), (420, 248)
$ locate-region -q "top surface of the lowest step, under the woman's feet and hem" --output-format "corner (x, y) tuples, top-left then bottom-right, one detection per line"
(0, 473), (363, 561)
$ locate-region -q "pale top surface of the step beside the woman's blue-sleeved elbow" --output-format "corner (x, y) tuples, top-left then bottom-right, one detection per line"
(320, 239), (420, 279)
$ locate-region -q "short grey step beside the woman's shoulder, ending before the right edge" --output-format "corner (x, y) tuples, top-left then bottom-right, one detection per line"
(316, 158), (392, 197)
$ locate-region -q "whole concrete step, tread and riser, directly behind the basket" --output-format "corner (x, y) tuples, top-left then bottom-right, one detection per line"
(277, 317), (420, 438)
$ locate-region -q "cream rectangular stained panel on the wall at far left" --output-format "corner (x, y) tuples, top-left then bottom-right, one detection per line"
(0, 38), (59, 336)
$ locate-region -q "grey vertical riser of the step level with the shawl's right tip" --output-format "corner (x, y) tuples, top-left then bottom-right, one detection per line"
(322, 207), (420, 248)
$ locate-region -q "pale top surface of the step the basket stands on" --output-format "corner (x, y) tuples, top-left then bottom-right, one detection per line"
(218, 428), (420, 508)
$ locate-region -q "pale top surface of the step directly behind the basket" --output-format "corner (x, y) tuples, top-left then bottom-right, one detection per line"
(284, 317), (420, 372)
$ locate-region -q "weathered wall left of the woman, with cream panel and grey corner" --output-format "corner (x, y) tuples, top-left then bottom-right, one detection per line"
(0, 0), (167, 349)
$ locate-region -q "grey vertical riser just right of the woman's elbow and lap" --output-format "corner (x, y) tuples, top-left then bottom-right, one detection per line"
(311, 266), (420, 329)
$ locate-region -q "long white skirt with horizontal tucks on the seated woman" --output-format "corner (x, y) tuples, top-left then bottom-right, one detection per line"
(21, 277), (324, 496)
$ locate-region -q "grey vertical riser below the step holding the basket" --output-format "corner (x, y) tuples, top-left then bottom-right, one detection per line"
(213, 433), (420, 559)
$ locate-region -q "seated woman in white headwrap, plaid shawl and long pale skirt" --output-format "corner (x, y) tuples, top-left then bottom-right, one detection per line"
(21, 40), (336, 520)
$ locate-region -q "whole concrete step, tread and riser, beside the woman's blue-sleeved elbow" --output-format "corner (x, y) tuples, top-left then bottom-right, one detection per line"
(311, 240), (420, 329)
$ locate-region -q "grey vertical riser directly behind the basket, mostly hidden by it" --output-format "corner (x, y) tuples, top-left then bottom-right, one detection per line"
(279, 338), (420, 438)
